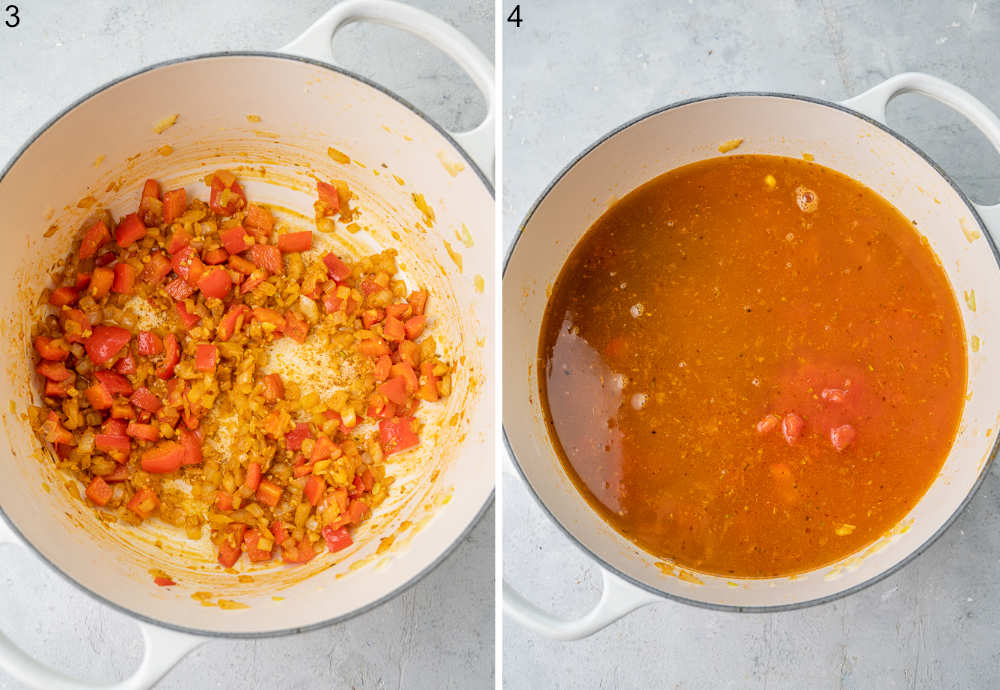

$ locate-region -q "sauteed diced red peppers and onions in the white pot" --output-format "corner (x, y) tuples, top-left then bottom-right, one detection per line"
(31, 170), (451, 567)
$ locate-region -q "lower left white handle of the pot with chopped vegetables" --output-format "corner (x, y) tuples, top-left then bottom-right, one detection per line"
(0, 518), (207, 690)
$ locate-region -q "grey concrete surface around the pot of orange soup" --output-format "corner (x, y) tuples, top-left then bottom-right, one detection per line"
(503, 0), (1000, 690)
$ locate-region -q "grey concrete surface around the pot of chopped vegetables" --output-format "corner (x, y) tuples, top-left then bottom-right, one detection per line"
(0, 0), (494, 690)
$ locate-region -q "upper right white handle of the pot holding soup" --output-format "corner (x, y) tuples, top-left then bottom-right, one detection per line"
(841, 72), (1000, 228)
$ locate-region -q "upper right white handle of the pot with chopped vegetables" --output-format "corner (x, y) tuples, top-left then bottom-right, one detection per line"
(281, 0), (496, 180)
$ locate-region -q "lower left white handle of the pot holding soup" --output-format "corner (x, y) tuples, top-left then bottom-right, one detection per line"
(503, 568), (660, 640)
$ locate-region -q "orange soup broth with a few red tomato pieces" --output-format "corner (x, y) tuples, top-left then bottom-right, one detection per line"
(539, 155), (966, 577)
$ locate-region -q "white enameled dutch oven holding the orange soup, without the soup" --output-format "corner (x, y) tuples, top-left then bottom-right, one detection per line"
(503, 73), (1000, 639)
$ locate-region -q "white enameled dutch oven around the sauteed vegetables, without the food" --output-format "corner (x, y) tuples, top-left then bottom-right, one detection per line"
(0, 0), (495, 689)
